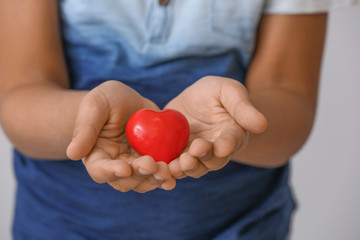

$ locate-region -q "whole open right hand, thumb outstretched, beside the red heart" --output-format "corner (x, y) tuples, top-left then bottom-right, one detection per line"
(165, 76), (267, 178)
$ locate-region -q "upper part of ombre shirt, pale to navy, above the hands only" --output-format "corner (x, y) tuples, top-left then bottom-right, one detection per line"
(58, 0), (263, 106)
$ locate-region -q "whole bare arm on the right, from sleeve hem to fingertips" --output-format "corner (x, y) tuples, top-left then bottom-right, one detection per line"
(167, 14), (326, 178)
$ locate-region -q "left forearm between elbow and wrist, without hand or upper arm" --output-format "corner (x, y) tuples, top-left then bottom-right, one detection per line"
(0, 83), (86, 160)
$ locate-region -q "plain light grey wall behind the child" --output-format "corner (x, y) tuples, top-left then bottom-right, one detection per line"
(0, 3), (360, 240)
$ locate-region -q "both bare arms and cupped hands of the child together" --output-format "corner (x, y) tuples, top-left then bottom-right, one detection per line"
(0, 0), (326, 192)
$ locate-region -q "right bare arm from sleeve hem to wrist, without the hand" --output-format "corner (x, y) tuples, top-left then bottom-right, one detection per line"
(238, 14), (327, 167)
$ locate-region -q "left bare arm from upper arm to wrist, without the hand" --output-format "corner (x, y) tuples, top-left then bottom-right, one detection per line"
(0, 0), (80, 159)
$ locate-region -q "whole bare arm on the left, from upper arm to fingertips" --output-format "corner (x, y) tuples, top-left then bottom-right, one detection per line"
(0, 0), (175, 192)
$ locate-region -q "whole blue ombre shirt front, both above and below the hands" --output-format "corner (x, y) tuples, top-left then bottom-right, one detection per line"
(13, 0), (342, 240)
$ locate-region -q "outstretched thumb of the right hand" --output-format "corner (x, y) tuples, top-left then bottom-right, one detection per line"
(220, 79), (267, 133)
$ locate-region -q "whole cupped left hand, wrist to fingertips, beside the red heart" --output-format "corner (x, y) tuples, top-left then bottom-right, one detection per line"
(67, 81), (175, 193)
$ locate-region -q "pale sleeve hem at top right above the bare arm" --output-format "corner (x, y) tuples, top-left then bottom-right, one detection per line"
(265, 0), (360, 14)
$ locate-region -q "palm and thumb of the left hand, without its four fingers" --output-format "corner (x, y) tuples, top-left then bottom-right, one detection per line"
(67, 81), (158, 159)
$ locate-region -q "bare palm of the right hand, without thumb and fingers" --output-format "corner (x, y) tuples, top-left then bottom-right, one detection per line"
(166, 78), (244, 154)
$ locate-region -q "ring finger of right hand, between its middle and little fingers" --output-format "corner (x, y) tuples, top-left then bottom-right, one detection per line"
(180, 153), (209, 178)
